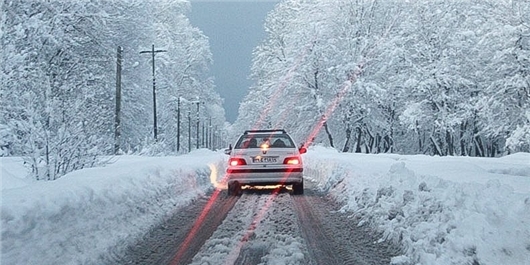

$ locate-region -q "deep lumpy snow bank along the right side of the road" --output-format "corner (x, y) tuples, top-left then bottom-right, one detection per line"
(304, 147), (530, 265)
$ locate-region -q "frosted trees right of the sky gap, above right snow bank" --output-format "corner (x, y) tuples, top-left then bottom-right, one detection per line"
(233, 0), (530, 156)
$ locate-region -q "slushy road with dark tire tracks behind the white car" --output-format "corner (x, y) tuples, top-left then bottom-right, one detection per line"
(113, 182), (399, 264)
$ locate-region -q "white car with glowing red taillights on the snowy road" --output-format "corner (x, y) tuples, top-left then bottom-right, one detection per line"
(225, 129), (307, 195)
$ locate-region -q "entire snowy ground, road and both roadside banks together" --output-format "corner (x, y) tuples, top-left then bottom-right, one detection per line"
(0, 150), (530, 265)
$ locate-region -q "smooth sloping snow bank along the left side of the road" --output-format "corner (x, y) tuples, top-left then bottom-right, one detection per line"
(0, 150), (226, 264)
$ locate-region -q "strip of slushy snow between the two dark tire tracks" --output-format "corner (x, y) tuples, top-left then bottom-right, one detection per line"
(192, 191), (311, 265)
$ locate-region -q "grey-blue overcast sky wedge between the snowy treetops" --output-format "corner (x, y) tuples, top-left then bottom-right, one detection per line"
(189, 0), (279, 123)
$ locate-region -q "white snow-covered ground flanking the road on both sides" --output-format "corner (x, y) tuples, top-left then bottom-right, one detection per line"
(0, 147), (530, 265)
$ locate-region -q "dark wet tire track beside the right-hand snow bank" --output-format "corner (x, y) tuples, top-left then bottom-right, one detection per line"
(293, 184), (399, 265)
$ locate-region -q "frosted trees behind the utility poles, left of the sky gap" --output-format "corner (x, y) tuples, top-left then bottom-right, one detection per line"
(0, 0), (224, 180)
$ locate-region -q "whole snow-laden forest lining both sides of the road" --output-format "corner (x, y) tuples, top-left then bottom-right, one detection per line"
(0, 0), (530, 180)
